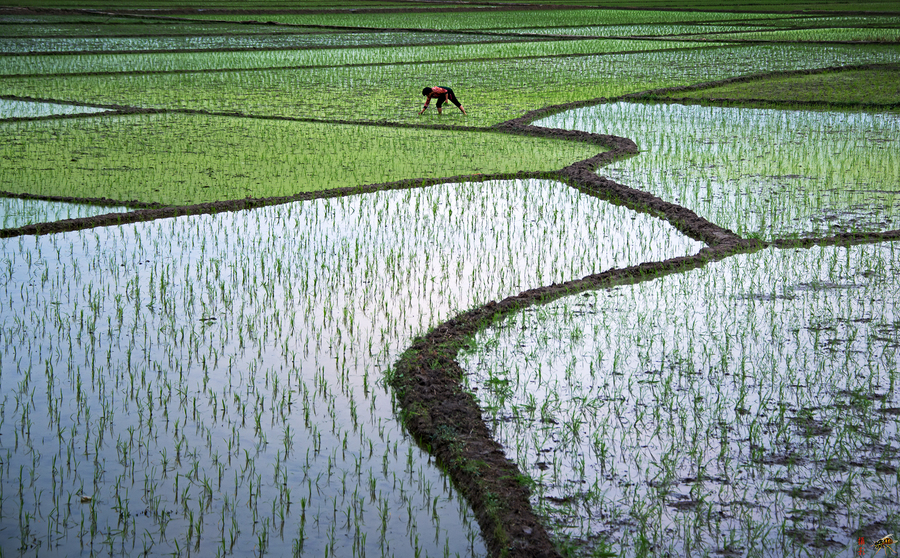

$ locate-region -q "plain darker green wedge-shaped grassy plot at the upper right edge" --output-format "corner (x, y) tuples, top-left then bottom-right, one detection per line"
(666, 64), (900, 106)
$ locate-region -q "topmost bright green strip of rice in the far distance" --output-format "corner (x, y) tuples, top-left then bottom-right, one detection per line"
(190, 9), (771, 31)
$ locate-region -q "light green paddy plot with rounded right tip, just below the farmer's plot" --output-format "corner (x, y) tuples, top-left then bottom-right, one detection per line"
(0, 114), (602, 205)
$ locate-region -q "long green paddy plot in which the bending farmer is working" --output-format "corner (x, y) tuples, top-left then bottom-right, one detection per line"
(0, 45), (900, 126)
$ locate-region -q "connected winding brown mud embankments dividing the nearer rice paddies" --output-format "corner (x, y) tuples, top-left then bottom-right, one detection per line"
(0, 77), (900, 557)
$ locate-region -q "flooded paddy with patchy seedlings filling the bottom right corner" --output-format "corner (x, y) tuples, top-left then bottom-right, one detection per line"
(460, 243), (900, 556)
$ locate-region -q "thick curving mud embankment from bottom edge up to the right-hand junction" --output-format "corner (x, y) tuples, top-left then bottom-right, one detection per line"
(388, 242), (762, 557)
